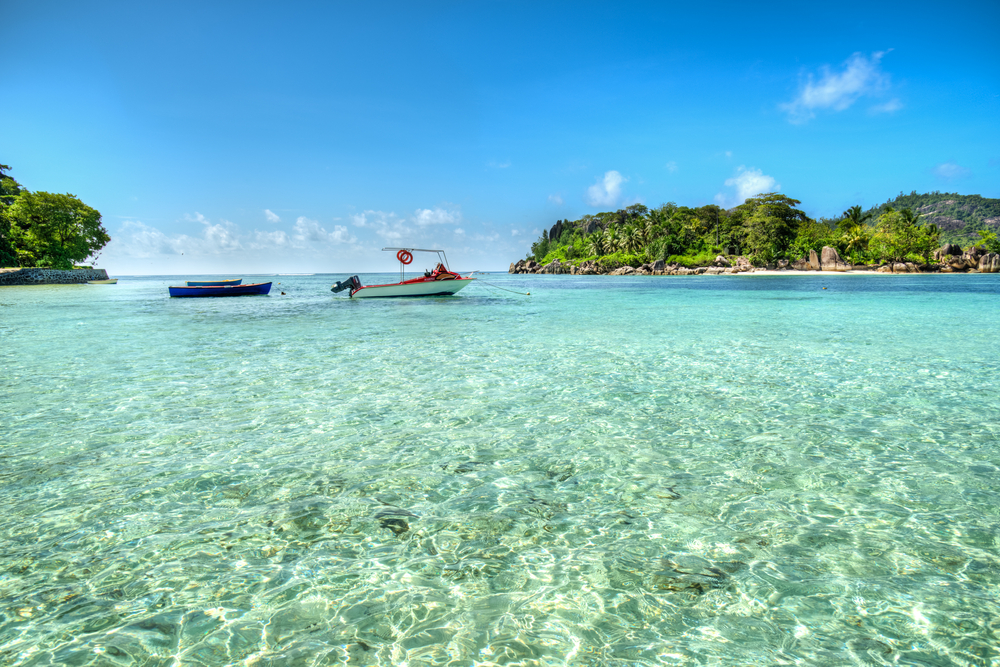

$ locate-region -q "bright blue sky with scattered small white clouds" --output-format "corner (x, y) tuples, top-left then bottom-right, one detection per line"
(0, 0), (1000, 275)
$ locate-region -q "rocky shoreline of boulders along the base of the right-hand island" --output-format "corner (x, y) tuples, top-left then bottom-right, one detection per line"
(507, 244), (1000, 276)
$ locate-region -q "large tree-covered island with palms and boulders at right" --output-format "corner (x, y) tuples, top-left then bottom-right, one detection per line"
(509, 192), (1000, 275)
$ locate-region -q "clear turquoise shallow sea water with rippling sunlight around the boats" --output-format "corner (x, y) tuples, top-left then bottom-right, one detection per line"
(0, 275), (1000, 665)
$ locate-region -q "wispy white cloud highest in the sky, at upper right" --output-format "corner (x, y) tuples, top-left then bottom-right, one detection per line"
(779, 51), (898, 123)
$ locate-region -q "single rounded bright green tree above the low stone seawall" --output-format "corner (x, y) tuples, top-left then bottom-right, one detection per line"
(7, 190), (111, 269)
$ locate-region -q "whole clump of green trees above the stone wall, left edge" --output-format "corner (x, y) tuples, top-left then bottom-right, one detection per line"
(0, 164), (111, 270)
